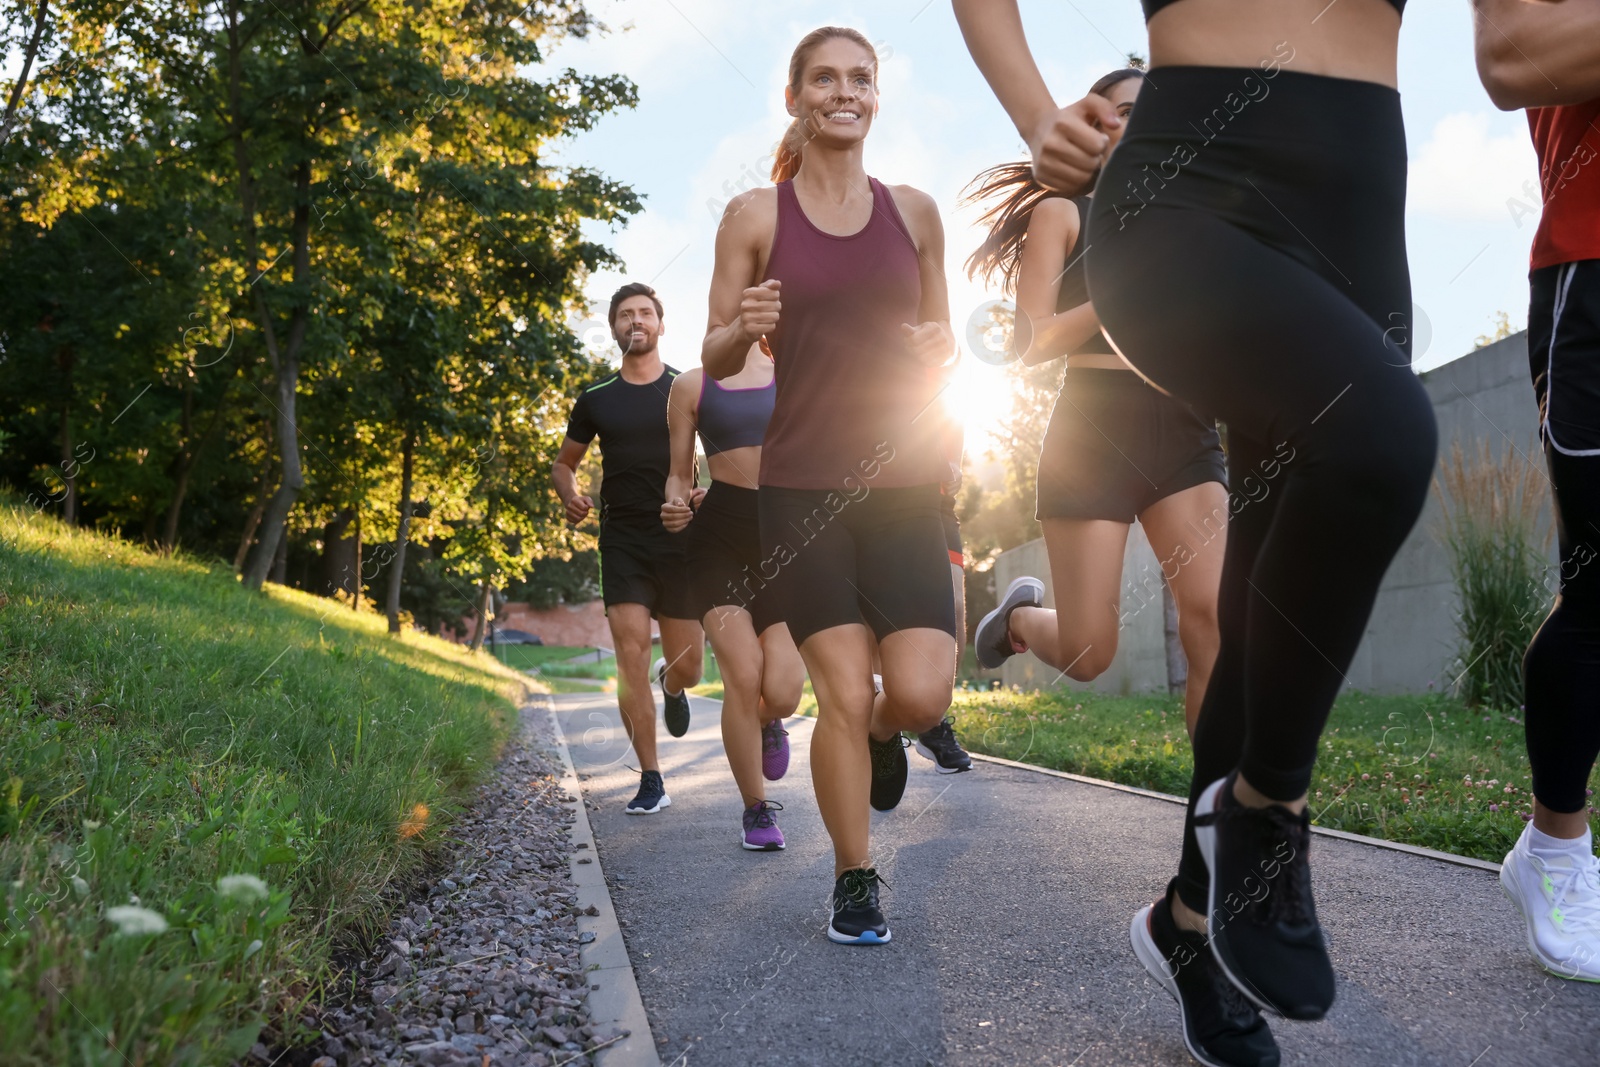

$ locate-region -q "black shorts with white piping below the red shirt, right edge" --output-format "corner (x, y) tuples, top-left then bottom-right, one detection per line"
(1528, 259), (1600, 456)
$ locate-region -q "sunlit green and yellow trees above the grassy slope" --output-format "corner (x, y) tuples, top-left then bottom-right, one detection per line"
(0, 0), (640, 622)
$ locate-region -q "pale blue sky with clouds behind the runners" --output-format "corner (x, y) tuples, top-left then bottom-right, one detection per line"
(547, 0), (1539, 447)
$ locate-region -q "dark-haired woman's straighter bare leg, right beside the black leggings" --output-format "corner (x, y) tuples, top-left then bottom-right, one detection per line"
(1139, 482), (1227, 737)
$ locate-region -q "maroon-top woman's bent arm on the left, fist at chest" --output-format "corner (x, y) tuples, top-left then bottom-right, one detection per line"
(701, 189), (779, 381)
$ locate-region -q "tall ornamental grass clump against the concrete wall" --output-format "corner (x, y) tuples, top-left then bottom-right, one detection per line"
(1434, 442), (1550, 709)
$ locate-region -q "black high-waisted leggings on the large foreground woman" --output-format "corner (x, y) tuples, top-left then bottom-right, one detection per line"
(1088, 67), (1435, 912)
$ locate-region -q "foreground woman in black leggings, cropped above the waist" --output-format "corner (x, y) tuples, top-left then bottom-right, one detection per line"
(954, 0), (1437, 1064)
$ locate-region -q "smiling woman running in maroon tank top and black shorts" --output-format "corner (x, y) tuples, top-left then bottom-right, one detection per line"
(702, 27), (958, 944)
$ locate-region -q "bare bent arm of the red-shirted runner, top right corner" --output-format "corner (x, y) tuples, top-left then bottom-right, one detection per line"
(1472, 0), (1600, 110)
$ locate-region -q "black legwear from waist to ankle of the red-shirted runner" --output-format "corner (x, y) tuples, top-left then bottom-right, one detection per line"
(1523, 259), (1600, 813)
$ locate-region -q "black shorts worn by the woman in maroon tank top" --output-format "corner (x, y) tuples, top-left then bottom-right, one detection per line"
(760, 485), (955, 645)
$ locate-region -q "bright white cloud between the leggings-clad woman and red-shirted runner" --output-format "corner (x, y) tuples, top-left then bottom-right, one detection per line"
(1408, 112), (1539, 221)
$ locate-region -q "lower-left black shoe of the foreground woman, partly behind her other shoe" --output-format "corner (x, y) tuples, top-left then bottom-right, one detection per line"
(1128, 897), (1278, 1067)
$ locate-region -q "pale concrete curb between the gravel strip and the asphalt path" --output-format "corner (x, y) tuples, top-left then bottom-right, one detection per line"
(534, 694), (661, 1067)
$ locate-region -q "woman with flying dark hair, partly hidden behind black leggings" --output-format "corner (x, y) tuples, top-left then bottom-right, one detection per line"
(966, 67), (1227, 736)
